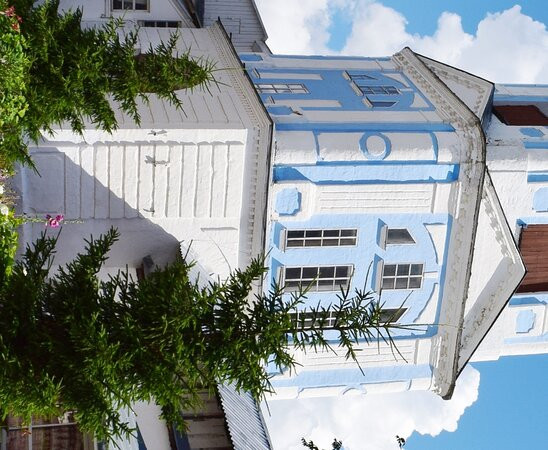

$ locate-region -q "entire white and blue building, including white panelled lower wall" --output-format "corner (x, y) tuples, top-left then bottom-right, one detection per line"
(18, 0), (548, 449)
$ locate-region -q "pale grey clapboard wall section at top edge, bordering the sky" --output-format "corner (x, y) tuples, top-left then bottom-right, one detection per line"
(204, 0), (267, 52)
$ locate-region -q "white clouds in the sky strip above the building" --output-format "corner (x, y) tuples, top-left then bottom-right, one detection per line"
(258, 0), (548, 83)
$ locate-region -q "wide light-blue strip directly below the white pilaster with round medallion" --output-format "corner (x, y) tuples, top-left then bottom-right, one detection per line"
(273, 164), (459, 185)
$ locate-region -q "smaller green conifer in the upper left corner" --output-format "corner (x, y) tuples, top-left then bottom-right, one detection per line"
(0, 0), (214, 171)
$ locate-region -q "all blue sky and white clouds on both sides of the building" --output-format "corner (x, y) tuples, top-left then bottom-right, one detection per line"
(256, 0), (548, 450)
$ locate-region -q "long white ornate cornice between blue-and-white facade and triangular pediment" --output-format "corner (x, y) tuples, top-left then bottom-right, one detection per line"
(392, 47), (486, 398)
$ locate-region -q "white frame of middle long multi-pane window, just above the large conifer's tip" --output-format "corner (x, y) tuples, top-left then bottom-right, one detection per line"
(281, 264), (354, 292)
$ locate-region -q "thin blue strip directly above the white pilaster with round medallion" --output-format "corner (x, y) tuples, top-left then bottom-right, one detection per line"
(276, 122), (455, 133)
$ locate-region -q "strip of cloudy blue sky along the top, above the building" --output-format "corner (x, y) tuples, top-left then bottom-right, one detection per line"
(257, 0), (548, 83)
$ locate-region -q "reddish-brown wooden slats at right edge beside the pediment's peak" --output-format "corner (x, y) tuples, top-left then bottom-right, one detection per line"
(518, 225), (548, 292)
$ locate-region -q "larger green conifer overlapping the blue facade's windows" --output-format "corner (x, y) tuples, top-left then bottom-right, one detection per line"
(0, 230), (402, 439)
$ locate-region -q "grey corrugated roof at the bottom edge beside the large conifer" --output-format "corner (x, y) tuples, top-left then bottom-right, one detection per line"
(218, 385), (272, 450)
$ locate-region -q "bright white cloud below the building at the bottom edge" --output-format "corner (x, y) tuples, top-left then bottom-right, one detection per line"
(264, 366), (480, 450)
